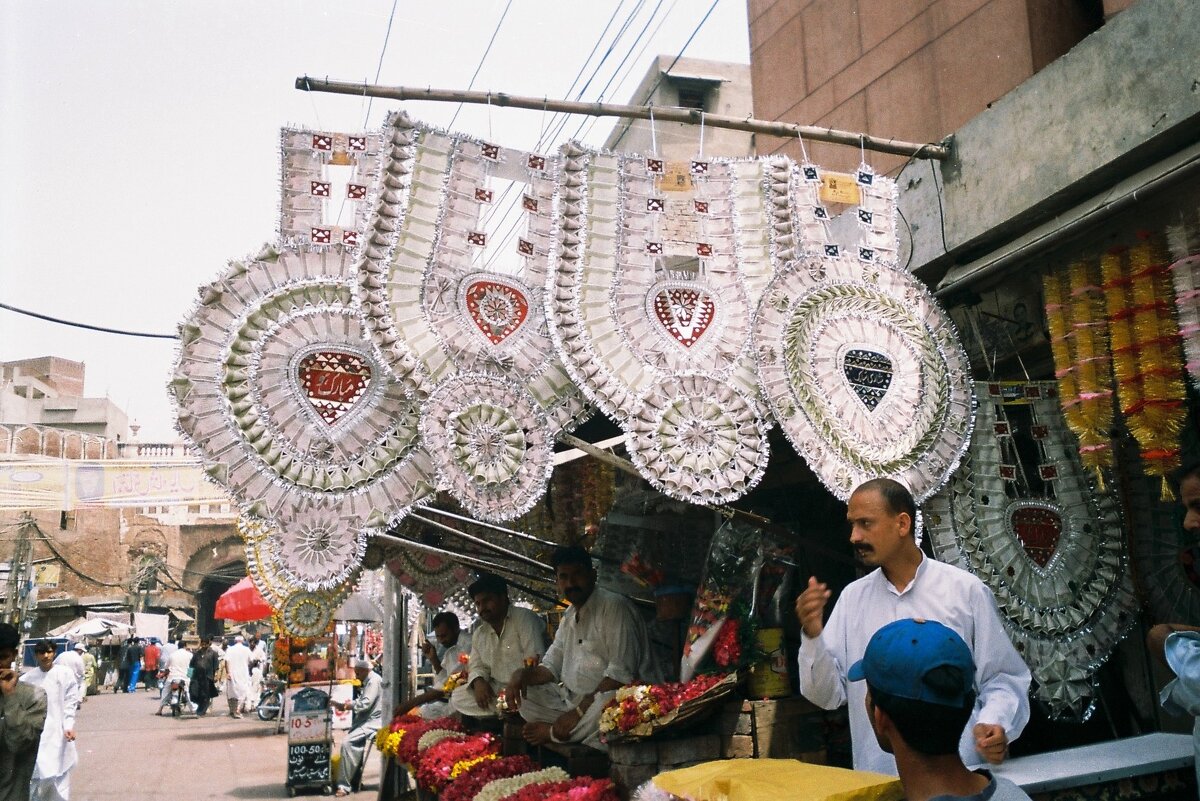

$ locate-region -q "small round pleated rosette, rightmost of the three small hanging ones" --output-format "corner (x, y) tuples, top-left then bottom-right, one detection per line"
(625, 373), (769, 505)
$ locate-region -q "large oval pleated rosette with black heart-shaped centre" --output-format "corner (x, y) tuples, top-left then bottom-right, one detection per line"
(756, 257), (973, 502)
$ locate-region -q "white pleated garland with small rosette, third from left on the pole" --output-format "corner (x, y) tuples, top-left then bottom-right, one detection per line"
(548, 143), (792, 504)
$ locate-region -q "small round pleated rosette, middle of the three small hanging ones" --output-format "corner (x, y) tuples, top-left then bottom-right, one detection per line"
(421, 374), (554, 520)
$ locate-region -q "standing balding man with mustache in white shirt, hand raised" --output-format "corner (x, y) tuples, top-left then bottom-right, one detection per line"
(796, 478), (1030, 775)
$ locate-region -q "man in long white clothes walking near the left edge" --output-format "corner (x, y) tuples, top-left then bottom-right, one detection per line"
(20, 640), (79, 801)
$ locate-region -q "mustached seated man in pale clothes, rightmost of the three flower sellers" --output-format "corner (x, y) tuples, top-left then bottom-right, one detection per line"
(508, 546), (656, 751)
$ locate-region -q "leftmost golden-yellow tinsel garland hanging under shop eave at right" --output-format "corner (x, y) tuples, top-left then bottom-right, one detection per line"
(1044, 261), (1114, 490)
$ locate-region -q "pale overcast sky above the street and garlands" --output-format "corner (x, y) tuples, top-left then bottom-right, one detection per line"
(0, 0), (749, 442)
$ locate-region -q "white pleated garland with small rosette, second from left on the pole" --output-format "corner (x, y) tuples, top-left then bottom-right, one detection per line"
(358, 114), (587, 520)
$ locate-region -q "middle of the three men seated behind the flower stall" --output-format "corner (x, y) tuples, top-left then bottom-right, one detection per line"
(450, 573), (546, 717)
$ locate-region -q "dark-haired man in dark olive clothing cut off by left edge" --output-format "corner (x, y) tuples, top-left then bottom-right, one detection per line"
(0, 624), (46, 801)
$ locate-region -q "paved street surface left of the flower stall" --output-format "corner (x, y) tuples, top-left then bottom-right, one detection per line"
(71, 691), (379, 801)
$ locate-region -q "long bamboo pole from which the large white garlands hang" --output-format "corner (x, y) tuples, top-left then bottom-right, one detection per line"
(295, 76), (950, 161)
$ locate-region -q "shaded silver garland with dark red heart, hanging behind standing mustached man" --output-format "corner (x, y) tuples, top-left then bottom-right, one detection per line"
(925, 383), (1139, 719)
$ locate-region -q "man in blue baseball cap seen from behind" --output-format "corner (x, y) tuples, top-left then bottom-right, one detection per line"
(847, 619), (1030, 801)
